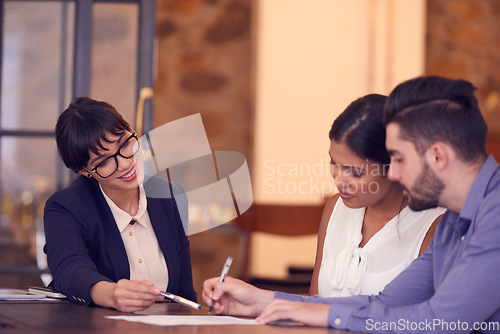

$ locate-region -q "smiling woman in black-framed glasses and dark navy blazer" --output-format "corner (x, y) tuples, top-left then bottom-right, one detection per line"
(44, 98), (196, 312)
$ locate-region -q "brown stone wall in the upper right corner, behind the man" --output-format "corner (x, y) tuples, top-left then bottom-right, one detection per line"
(425, 0), (500, 141)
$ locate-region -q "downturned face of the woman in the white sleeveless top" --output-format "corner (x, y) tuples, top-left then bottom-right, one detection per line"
(329, 140), (392, 208)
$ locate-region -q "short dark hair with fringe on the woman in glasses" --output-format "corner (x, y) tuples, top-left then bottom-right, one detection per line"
(55, 97), (130, 172)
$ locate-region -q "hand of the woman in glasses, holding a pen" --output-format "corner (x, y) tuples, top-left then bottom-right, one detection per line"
(90, 279), (164, 312)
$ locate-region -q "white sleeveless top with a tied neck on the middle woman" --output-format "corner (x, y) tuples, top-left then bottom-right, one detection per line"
(318, 198), (445, 298)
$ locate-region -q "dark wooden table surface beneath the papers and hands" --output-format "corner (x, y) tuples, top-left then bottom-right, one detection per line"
(0, 300), (362, 334)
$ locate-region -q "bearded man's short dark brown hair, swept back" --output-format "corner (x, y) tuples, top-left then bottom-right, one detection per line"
(384, 76), (488, 162)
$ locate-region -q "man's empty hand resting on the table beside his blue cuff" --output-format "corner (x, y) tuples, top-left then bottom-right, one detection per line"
(256, 299), (331, 327)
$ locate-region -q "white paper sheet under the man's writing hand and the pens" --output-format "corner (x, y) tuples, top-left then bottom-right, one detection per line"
(106, 315), (260, 326)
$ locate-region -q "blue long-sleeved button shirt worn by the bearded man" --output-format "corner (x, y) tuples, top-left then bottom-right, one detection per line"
(275, 156), (500, 333)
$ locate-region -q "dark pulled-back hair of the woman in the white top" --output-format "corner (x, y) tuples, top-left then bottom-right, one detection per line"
(329, 94), (390, 166)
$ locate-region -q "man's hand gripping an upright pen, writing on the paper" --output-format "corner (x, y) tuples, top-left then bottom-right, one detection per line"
(203, 277), (274, 317)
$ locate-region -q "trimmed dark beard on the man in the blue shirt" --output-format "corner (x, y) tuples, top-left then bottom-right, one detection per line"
(403, 161), (444, 211)
